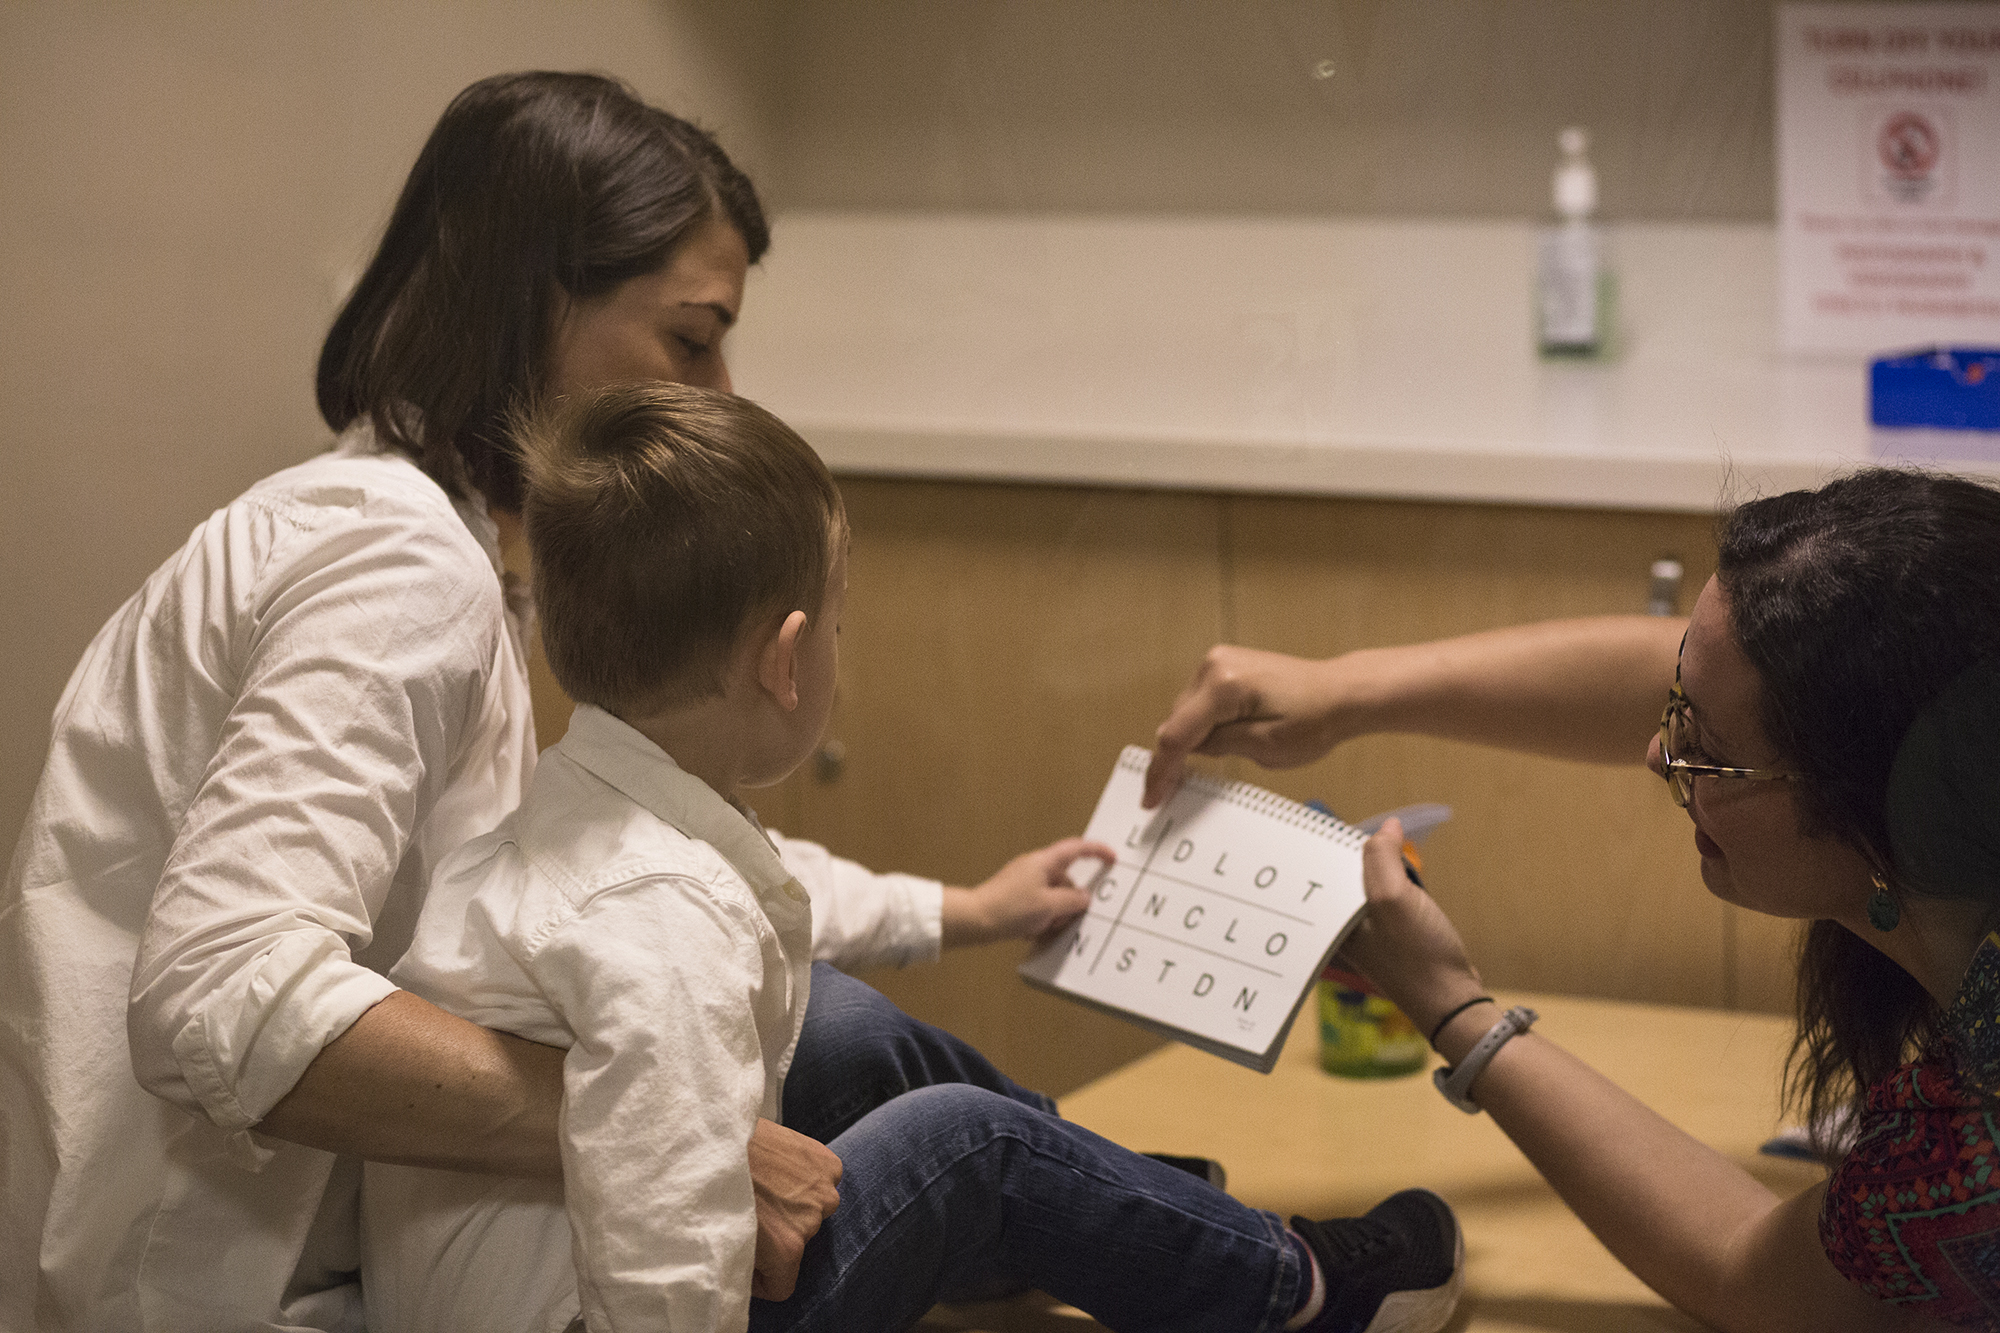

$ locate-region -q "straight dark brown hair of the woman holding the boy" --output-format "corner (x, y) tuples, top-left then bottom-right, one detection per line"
(318, 72), (770, 510)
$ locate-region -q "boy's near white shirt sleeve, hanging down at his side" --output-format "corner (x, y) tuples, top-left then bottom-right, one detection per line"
(528, 877), (790, 1333)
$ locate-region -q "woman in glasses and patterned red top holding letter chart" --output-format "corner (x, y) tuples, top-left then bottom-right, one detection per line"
(1150, 468), (2000, 1333)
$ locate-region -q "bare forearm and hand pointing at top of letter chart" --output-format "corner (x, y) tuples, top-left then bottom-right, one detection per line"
(1146, 616), (1686, 807)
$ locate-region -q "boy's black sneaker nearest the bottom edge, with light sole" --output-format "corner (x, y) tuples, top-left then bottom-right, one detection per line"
(1292, 1189), (1466, 1333)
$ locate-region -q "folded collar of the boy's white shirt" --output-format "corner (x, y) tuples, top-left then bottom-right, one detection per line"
(556, 705), (806, 905)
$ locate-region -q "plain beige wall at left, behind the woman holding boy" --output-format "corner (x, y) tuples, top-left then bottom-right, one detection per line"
(0, 0), (772, 847)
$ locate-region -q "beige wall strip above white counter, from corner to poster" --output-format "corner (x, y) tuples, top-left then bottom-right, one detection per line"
(774, 0), (1774, 220)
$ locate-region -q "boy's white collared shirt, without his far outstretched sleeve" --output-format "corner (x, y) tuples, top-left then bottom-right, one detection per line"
(362, 707), (812, 1333)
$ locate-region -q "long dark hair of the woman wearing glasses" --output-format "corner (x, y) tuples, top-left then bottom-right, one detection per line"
(1718, 468), (2000, 1123)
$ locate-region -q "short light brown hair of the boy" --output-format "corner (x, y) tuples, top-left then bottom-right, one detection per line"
(514, 382), (846, 717)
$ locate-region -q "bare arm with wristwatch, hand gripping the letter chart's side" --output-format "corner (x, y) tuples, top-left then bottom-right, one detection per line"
(1344, 821), (1944, 1333)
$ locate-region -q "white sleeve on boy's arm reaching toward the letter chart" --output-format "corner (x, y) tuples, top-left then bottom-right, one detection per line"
(770, 831), (944, 971)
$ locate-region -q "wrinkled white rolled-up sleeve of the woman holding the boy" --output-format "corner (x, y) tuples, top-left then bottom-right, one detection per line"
(126, 502), (506, 1129)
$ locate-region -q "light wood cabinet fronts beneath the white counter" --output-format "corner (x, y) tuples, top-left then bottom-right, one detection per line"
(510, 478), (1794, 1093)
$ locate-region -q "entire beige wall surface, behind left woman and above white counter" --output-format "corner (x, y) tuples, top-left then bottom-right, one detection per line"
(0, 0), (1856, 956)
